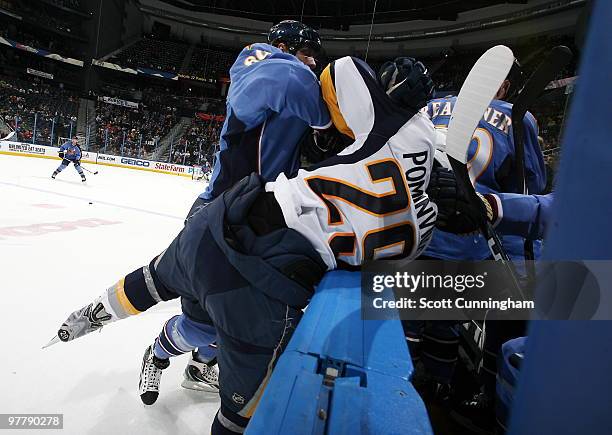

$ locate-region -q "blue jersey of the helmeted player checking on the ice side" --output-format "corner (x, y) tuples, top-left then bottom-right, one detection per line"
(200, 43), (331, 199)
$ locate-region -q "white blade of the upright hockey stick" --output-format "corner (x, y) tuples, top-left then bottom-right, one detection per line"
(446, 45), (514, 163)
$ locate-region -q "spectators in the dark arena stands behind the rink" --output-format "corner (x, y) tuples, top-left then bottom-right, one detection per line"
(0, 28), (576, 177)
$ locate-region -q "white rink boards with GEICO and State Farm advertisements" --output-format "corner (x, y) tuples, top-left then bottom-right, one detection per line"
(0, 141), (193, 178)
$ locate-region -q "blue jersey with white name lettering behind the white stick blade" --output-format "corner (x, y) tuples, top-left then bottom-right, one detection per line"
(425, 97), (546, 260)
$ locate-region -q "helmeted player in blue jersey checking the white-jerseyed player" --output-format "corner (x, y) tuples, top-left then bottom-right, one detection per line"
(170, 21), (331, 391)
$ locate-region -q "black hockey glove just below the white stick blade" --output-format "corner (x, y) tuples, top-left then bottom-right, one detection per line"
(427, 166), (496, 234)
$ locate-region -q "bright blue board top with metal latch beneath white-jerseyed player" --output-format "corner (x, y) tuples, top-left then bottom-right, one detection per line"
(246, 271), (432, 435)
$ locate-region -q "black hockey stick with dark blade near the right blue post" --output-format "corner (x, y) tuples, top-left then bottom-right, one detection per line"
(512, 45), (572, 283)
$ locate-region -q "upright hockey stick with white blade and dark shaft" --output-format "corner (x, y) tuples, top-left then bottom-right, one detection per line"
(446, 45), (525, 299)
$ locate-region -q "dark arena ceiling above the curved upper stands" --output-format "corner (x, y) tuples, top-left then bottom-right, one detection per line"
(155, 0), (527, 30)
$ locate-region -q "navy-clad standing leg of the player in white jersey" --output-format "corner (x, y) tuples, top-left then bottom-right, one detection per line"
(207, 287), (302, 435)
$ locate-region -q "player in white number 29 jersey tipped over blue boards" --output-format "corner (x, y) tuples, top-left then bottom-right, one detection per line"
(49, 57), (440, 435)
